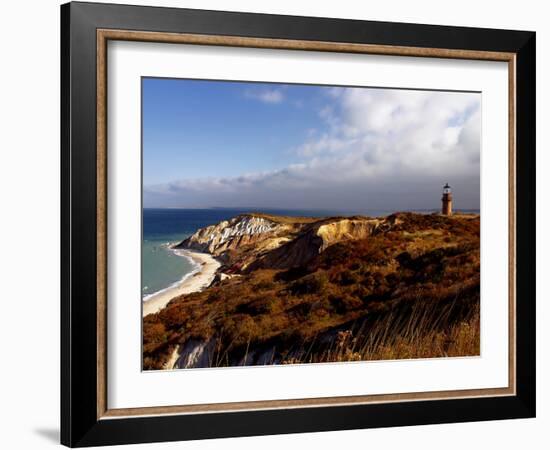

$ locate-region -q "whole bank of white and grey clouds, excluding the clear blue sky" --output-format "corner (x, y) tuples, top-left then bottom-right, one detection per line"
(144, 88), (481, 211)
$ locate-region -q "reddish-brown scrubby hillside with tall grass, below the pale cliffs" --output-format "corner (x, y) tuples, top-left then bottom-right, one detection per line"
(143, 213), (480, 369)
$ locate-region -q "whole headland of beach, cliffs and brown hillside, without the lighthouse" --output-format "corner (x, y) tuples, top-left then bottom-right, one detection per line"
(143, 213), (480, 370)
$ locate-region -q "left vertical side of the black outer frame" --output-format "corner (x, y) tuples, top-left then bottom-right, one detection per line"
(60, 2), (103, 447)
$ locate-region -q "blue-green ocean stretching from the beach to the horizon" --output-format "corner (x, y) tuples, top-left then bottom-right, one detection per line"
(141, 208), (479, 300)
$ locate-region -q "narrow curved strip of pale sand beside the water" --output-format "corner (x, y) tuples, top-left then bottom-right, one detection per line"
(142, 250), (220, 317)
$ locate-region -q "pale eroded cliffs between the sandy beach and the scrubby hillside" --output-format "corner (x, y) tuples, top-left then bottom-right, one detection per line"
(177, 214), (395, 273)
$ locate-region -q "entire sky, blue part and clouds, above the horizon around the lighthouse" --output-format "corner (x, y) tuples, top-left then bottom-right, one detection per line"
(142, 78), (481, 211)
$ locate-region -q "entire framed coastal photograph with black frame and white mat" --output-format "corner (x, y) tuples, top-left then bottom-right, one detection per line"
(61, 3), (535, 447)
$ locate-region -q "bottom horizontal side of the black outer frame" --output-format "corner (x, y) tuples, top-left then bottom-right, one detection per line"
(75, 396), (533, 447)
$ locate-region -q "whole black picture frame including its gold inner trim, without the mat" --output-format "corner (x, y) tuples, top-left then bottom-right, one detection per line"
(61, 2), (536, 447)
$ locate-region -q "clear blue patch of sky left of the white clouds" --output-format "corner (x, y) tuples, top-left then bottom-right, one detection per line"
(143, 78), (326, 185)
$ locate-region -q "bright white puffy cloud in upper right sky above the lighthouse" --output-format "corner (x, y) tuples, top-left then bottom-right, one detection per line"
(296, 88), (480, 177)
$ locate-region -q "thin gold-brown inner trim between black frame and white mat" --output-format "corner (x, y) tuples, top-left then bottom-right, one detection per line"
(97, 29), (516, 420)
